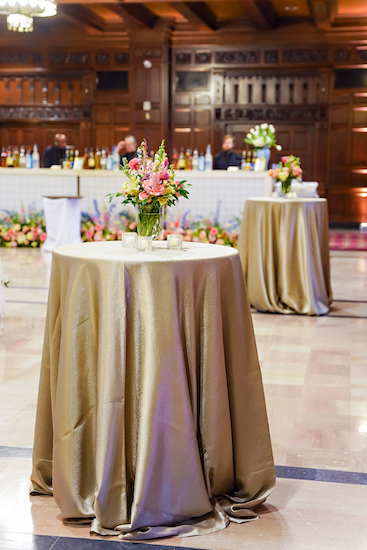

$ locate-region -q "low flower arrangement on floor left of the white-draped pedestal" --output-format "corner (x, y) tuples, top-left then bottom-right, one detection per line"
(0, 208), (47, 248)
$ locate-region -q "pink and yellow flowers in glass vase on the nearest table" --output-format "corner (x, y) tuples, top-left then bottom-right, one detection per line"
(108, 140), (189, 239)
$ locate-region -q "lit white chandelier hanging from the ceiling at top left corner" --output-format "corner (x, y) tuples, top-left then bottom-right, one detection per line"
(0, 0), (57, 32)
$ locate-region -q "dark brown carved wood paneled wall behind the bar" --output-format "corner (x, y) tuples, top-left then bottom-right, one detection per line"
(0, 37), (367, 222)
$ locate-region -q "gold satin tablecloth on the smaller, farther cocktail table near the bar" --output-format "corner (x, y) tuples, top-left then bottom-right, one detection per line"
(238, 198), (332, 315)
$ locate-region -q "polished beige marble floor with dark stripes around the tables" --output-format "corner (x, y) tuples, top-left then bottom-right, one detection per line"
(0, 249), (367, 550)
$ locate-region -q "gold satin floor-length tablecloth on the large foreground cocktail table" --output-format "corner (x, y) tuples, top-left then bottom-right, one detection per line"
(31, 242), (275, 540)
